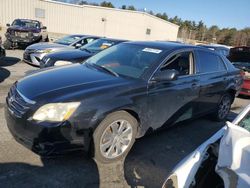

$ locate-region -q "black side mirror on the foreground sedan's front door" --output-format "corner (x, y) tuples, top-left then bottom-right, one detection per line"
(152, 70), (179, 81)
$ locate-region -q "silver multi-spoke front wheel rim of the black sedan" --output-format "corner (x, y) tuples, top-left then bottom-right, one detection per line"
(100, 120), (133, 159)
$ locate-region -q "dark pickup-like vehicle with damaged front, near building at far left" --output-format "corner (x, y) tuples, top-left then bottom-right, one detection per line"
(4, 19), (49, 49)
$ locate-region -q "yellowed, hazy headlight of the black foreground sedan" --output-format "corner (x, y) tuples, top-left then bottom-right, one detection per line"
(32, 102), (80, 122)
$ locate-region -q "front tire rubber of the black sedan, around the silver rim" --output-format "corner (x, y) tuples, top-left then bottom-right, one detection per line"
(92, 111), (138, 163)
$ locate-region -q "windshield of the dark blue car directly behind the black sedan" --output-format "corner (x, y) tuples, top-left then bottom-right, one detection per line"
(80, 39), (118, 52)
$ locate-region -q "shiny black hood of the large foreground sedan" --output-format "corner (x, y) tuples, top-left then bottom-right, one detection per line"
(16, 63), (129, 101)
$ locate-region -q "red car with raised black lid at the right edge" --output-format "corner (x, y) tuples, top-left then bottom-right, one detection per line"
(229, 46), (250, 96)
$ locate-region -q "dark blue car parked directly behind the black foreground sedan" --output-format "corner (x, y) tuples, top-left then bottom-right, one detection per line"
(40, 38), (125, 68)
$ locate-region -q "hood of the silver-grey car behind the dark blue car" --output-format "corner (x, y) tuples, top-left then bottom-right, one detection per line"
(26, 42), (74, 50)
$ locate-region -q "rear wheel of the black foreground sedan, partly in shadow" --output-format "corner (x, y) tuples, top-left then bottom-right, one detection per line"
(213, 93), (233, 121)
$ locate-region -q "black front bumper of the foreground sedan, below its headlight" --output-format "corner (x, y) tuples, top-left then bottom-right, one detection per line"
(5, 106), (90, 156)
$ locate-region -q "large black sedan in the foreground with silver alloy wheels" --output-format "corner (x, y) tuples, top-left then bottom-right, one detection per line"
(6, 42), (242, 162)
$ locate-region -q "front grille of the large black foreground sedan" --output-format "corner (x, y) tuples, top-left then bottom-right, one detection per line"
(6, 86), (34, 118)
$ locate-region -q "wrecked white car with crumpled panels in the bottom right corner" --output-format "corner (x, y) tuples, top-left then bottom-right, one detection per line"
(163, 105), (250, 188)
